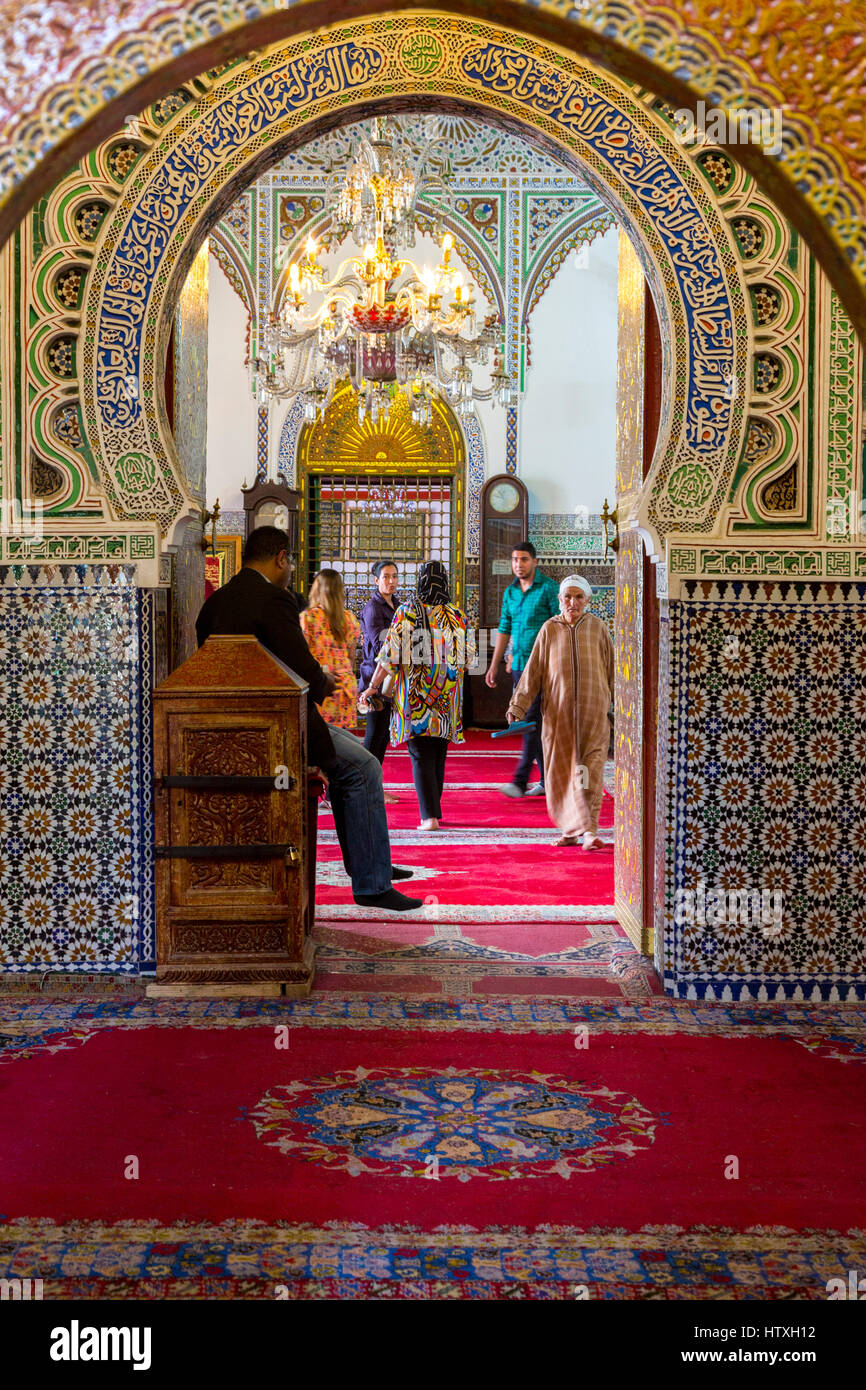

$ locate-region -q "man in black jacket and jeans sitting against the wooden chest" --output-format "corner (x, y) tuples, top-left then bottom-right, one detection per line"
(196, 525), (423, 912)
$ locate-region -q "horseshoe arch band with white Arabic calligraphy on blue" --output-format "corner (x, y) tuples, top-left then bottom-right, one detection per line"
(44, 17), (767, 556)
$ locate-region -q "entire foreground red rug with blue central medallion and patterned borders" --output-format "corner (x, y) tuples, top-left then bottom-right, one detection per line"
(0, 994), (866, 1300)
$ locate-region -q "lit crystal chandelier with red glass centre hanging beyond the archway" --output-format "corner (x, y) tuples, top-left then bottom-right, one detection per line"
(253, 118), (516, 425)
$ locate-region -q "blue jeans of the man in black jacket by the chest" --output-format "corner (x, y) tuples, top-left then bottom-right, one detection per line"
(328, 724), (391, 894)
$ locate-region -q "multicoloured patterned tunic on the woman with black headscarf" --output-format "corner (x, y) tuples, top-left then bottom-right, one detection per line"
(378, 599), (475, 746)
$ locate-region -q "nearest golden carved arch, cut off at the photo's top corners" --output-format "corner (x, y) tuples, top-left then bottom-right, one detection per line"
(0, 0), (866, 346)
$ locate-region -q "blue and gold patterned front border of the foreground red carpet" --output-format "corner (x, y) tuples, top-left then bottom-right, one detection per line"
(0, 1219), (866, 1300)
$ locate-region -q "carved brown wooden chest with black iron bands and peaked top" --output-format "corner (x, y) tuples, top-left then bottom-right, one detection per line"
(149, 637), (316, 995)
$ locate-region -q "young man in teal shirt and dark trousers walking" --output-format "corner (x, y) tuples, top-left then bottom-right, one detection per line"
(484, 541), (559, 796)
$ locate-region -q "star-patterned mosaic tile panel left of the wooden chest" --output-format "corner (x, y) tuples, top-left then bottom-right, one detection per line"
(0, 566), (153, 973)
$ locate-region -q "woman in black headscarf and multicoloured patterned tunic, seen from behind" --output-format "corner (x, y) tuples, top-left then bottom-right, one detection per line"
(361, 560), (475, 830)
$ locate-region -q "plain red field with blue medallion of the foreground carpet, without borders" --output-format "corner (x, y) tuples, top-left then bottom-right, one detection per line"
(0, 1027), (866, 1230)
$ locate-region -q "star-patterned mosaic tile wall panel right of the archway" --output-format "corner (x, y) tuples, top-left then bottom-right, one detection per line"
(664, 582), (866, 1001)
